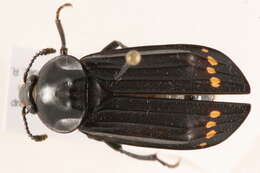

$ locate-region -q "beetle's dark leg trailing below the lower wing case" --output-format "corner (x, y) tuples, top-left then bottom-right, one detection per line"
(105, 142), (180, 168)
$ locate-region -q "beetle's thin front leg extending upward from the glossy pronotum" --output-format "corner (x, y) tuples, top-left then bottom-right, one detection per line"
(56, 3), (72, 55)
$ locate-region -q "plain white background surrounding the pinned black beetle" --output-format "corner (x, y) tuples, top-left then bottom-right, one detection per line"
(0, 0), (260, 173)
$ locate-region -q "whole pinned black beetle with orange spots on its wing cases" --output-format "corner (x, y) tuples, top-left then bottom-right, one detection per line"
(19, 4), (250, 167)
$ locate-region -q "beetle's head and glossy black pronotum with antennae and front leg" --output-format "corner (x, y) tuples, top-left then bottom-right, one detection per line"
(19, 3), (86, 141)
